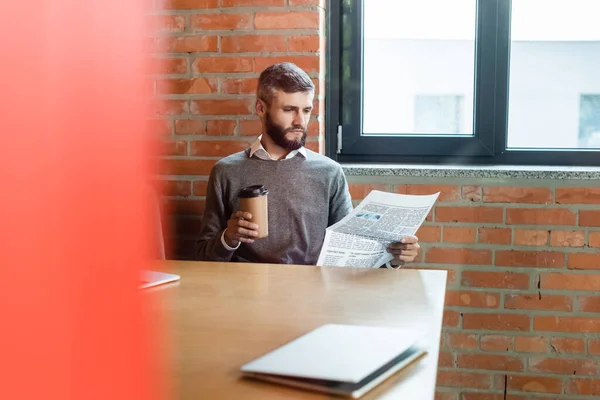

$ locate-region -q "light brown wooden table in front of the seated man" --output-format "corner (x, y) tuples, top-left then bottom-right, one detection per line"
(147, 261), (446, 400)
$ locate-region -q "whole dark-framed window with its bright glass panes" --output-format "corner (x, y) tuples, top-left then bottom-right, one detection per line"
(326, 0), (600, 165)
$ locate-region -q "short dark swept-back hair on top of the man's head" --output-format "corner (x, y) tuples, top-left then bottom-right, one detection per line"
(256, 62), (315, 105)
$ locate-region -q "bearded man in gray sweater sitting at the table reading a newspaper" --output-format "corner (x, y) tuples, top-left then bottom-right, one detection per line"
(194, 63), (419, 268)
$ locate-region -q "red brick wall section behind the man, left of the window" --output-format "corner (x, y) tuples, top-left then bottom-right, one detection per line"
(150, 0), (325, 258)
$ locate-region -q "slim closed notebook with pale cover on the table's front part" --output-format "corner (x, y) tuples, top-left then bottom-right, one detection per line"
(241, 324), (425, 398)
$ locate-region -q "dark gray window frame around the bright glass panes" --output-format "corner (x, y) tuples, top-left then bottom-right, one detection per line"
(325, 0), (600, 166)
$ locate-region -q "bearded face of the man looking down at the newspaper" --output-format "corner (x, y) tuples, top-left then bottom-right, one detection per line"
(264, 91), (314, 151)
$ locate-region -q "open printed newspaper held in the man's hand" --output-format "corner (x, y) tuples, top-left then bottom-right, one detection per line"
(317, 190), (439, 268)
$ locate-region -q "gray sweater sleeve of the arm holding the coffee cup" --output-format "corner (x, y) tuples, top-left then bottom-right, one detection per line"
(194, 168), (235, 261)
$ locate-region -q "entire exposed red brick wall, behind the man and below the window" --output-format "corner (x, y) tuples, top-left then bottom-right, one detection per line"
(151, 0), (600, 400)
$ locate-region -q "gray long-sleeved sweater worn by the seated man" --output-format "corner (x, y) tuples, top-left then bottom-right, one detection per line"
(194, 149), (352, 265)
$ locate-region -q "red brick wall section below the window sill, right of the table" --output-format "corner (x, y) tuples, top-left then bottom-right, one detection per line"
(348, 176), (600, 400)
